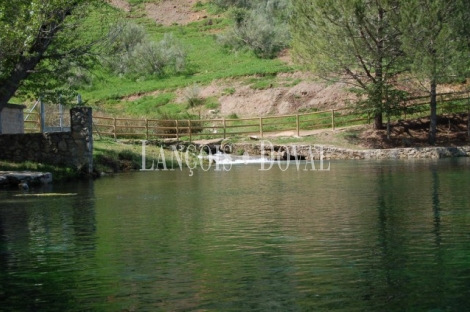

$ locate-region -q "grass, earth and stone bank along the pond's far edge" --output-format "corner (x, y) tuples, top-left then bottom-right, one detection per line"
(0, 115), (470, 188)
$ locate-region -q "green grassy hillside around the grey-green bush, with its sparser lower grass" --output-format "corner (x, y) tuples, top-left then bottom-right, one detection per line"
(79, 0), (293, 117)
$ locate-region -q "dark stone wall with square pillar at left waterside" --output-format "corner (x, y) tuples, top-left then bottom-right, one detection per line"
(0, 107), (93, 173)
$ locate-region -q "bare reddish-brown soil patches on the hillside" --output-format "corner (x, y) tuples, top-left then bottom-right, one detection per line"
(105, 0), (354, 117)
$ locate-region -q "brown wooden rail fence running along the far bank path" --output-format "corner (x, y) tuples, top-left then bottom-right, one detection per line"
(25, 92), (470, 141)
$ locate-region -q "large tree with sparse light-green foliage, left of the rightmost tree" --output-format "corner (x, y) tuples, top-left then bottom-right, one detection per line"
(291, 0), (403, 129)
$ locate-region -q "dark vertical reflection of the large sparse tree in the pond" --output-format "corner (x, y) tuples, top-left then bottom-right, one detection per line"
(363, 167), (407, 310)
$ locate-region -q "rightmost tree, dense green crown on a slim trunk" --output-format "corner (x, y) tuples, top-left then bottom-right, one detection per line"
(400, 0), (470, 144)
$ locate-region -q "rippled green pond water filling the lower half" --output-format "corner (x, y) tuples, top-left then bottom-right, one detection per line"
(0, 158), (470, 311)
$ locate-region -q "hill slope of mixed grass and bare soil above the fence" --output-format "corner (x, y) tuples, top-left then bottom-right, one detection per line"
(91, 0), (354, 117)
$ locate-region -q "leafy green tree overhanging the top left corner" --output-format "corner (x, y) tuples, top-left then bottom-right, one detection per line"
(0, 0), (104, 110)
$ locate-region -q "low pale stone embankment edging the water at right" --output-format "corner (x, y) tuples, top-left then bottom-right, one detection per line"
(228, 143), (470, 160)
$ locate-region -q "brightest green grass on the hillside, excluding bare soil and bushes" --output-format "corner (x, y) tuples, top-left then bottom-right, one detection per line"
(75, 0), (293, 115)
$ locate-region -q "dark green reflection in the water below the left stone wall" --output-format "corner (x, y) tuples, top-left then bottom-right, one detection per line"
(0, 184), (95, 311)
